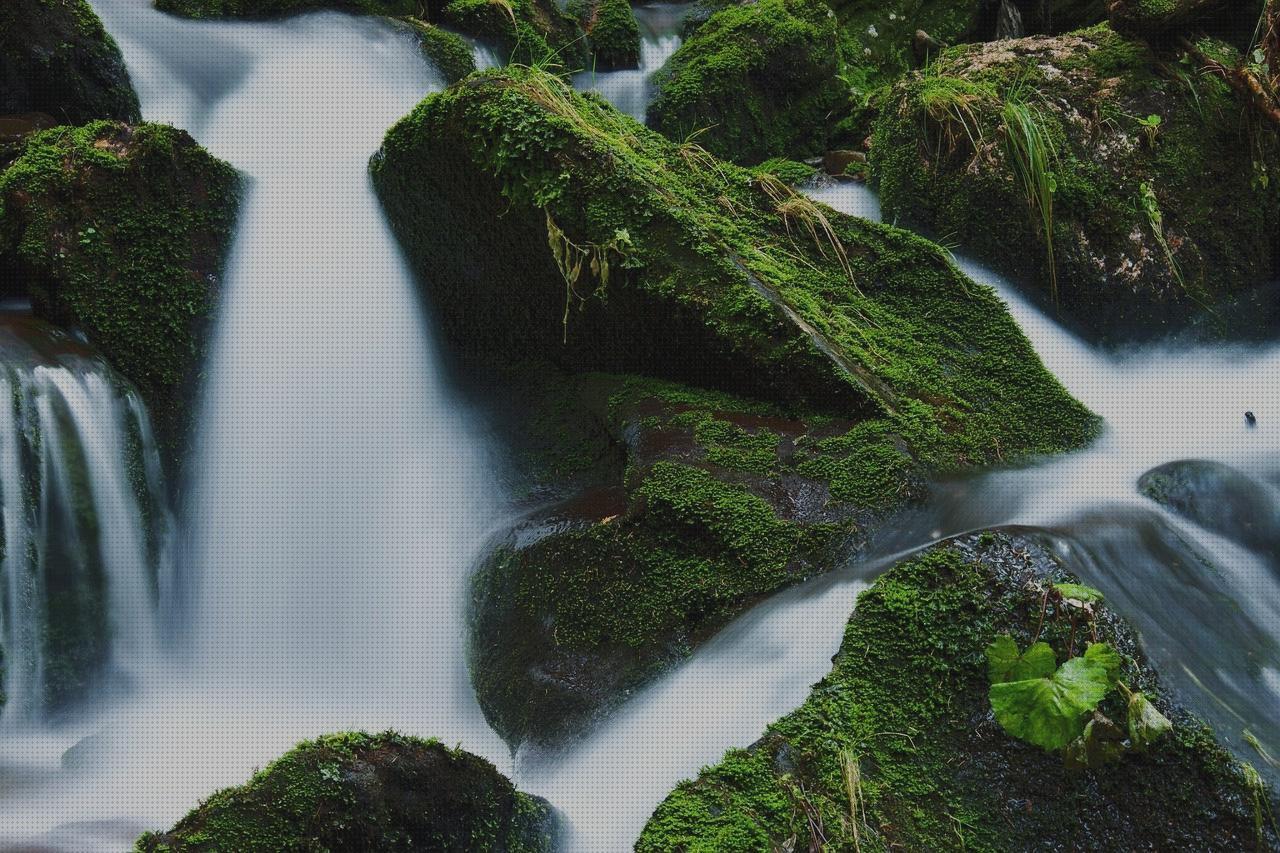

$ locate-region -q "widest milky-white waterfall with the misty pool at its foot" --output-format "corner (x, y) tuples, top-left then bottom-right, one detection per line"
(0, 0), (511, 849)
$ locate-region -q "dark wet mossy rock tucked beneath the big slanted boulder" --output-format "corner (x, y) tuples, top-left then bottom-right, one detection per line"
(471, 374), (924, 743)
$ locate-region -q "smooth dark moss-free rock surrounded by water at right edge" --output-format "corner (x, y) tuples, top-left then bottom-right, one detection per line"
(1138, 460), (1280, 565)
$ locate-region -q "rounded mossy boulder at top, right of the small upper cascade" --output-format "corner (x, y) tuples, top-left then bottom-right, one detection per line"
(646, 0), (846, 164)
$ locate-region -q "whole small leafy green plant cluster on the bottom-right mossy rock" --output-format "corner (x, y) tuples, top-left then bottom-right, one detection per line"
(987, 584), (1172, 768)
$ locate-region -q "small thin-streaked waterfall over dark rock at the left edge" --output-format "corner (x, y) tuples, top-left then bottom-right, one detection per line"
(0, 316), (172, 727)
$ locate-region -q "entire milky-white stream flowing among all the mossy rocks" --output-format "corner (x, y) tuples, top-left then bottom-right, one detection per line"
(0, 0), (1280, 852)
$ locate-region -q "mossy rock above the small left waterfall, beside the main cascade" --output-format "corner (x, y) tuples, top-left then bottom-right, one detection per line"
(0, 122), (239, 461)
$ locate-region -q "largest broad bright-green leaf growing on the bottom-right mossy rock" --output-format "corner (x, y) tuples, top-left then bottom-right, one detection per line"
(989, 657), (1111, 749)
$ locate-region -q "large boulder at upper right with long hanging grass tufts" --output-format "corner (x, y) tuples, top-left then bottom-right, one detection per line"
(870, 26), (1280, 338)
